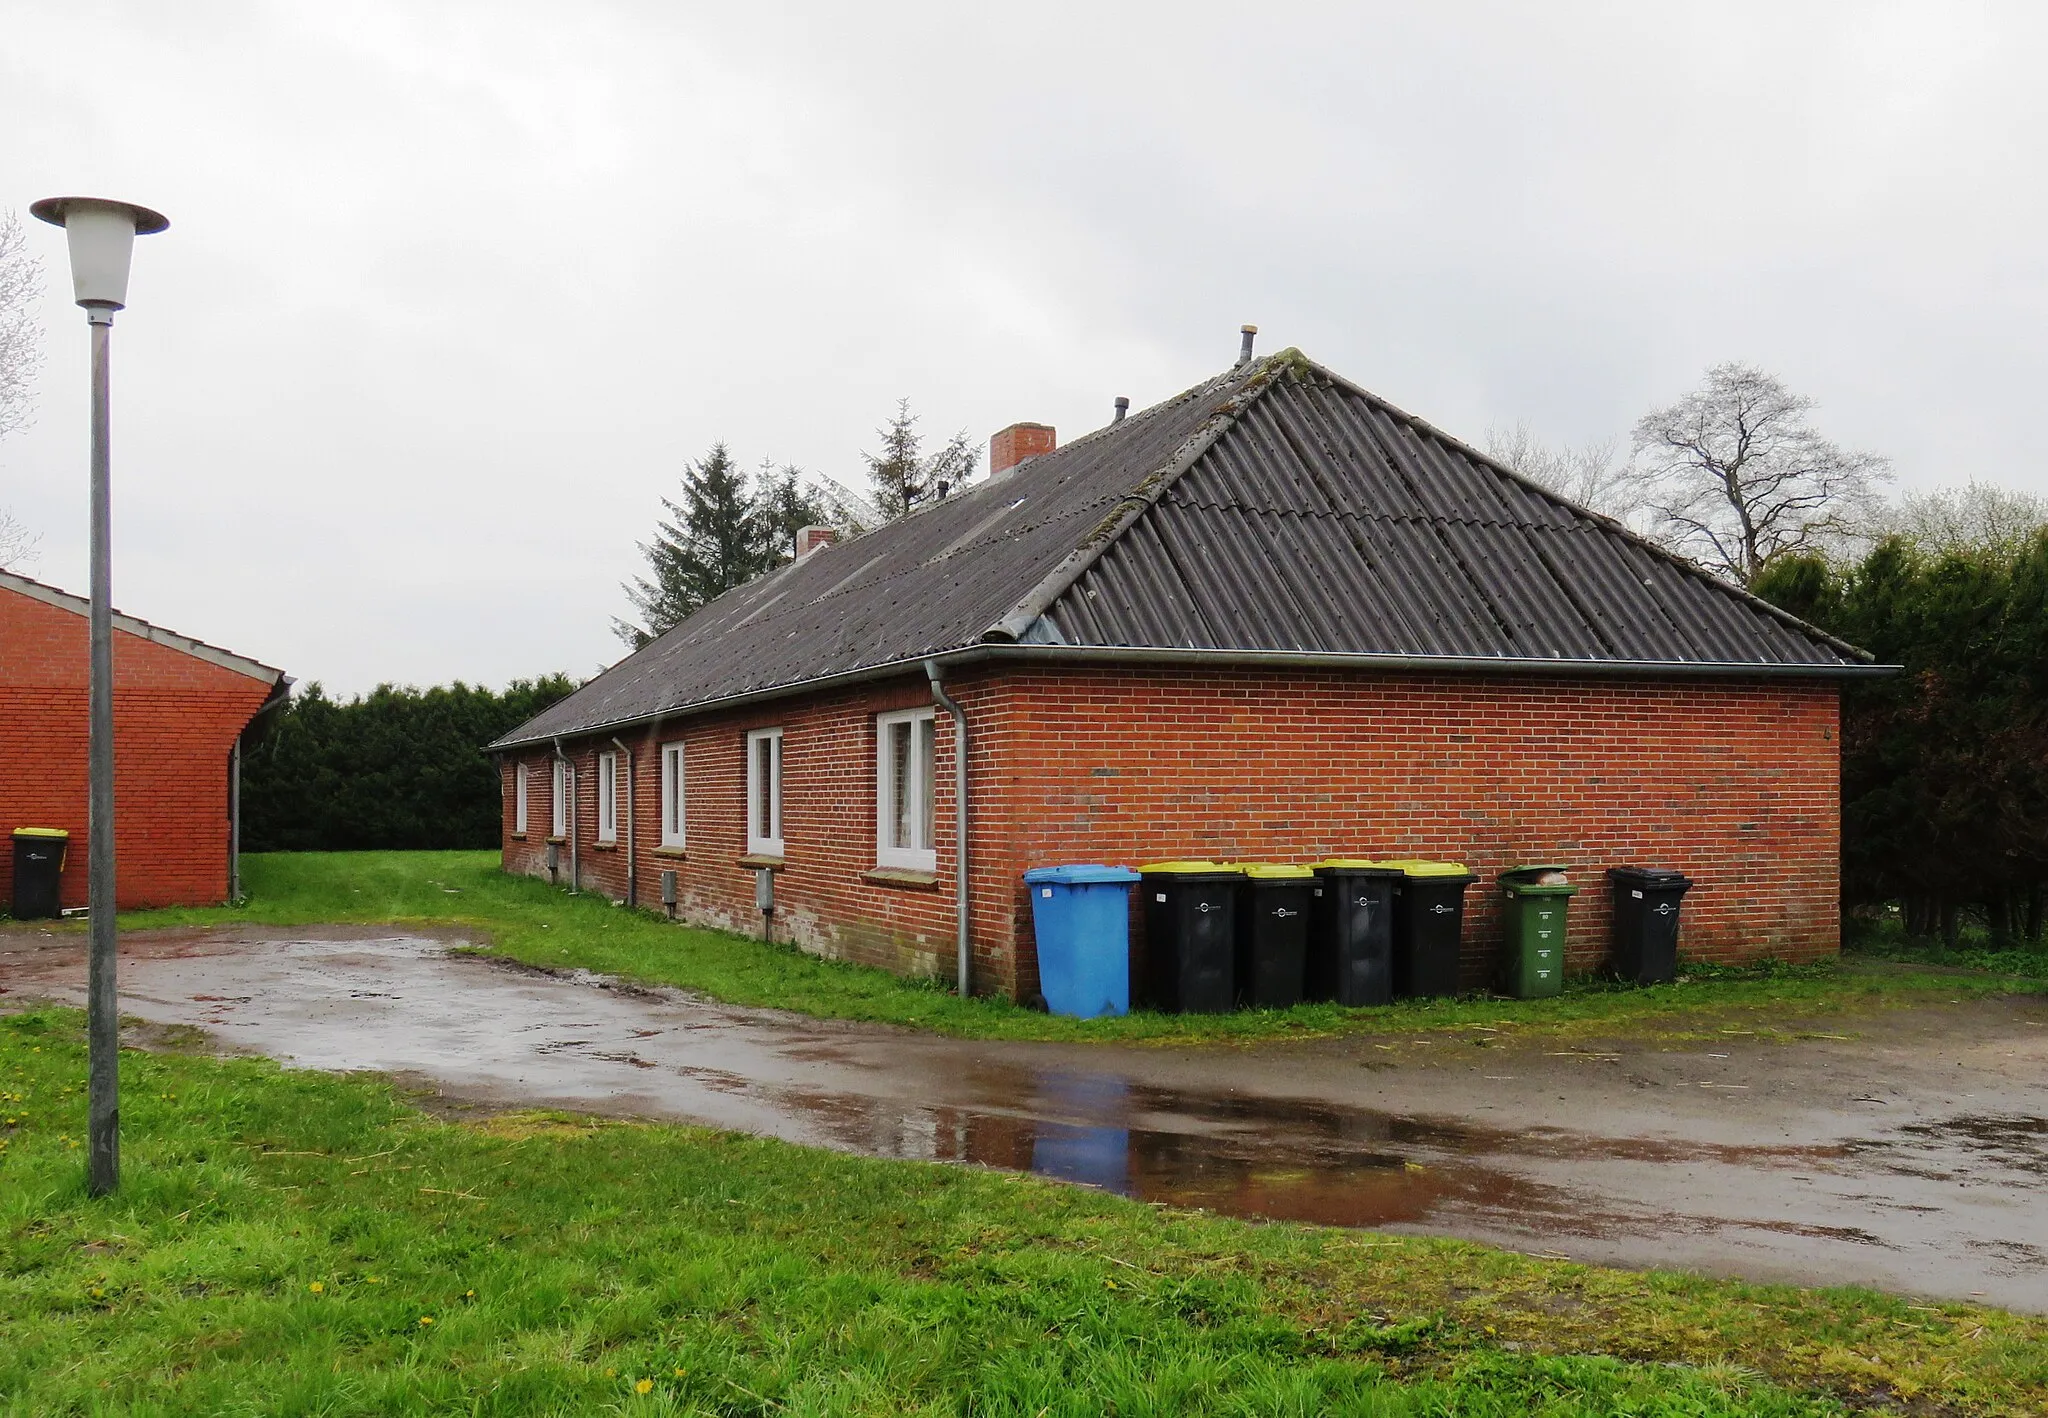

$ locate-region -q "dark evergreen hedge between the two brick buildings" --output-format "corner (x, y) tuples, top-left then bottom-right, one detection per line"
(242, 674), (575, 852)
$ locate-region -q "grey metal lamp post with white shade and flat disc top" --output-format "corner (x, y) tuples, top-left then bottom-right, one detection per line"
(29, 197), (170, 1197)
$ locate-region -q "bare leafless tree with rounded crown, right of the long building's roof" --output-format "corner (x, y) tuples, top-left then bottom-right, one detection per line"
(1632, 363), (1890, 586)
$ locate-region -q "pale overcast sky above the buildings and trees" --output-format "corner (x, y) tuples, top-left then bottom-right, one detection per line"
(0, 0), (2048, 691)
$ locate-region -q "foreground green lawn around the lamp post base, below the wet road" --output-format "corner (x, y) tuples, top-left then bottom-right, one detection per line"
(0, 1010), (2048, 1418)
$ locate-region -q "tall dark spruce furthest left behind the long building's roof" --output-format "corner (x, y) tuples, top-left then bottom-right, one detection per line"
(612, 441), (766, 650)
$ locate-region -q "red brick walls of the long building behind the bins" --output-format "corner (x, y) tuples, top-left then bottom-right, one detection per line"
(504, 668), (1841, 996)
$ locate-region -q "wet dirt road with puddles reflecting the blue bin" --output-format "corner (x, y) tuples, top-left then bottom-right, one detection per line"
(12, 928), (2048, 1311)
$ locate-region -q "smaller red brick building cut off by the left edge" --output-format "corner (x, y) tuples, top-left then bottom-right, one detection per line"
(0, 572), (291, 910)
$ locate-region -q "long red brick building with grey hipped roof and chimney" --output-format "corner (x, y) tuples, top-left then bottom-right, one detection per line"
(494, 350), (1882, 996)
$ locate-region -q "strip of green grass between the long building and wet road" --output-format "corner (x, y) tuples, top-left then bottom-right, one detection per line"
(96, 852), (2048, 1043)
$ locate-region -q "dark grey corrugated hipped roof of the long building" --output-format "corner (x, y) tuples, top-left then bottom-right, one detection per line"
(494, 350), (1868, 748)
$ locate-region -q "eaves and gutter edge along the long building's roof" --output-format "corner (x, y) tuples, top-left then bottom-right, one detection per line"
(485, 641), (1903, 752)
